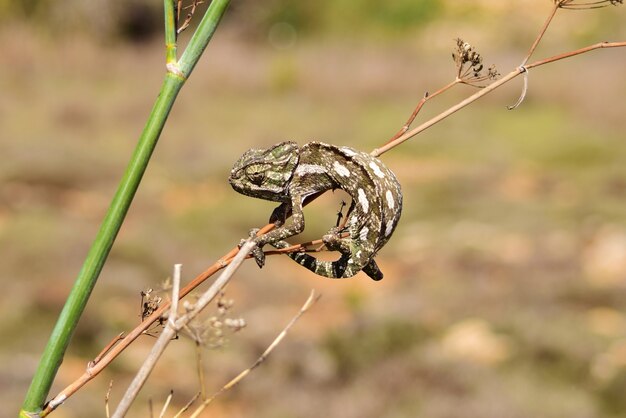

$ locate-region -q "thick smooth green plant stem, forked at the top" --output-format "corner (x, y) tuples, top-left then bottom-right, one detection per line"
(20, 0), (230, 417)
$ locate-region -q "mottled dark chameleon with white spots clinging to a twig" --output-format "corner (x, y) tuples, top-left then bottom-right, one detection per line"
(229, 141), (402, 280)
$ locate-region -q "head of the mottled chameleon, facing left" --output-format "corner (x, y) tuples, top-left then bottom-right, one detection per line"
(228, 142), (300, 201)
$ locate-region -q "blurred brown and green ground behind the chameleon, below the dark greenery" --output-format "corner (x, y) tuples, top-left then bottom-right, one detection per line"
(0, 0), (626, 418)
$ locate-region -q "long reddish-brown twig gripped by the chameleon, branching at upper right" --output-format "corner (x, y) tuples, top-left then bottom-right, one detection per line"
(40, 0), (626, 417)
